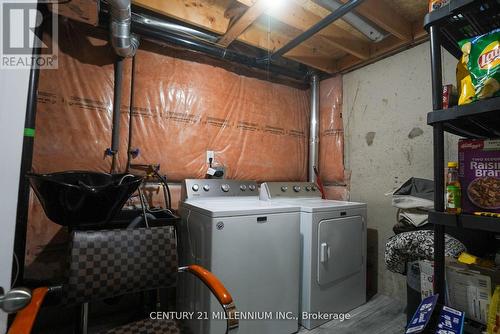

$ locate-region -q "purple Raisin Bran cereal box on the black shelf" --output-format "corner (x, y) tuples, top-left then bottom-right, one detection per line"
(458, 139), (500, 213)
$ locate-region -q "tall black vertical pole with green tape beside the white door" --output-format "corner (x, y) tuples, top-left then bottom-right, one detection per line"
(12, 4), (45, 289)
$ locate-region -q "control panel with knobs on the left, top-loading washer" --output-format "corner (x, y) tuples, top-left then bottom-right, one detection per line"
(181, 179), (259, 200)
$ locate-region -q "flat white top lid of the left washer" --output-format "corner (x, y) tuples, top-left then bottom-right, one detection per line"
(182, 197), (300, 217)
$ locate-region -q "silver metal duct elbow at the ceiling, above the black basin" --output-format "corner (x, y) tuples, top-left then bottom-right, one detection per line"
(108, 0), (139, 57)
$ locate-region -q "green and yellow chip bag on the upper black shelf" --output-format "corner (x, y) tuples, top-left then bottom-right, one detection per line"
(460, 29), (500, 100)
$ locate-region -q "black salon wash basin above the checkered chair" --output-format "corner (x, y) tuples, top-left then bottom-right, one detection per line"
(28, 171), (142, 228)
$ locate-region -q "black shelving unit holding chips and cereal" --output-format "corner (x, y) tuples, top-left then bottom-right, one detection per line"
(424, 0), (500, 303)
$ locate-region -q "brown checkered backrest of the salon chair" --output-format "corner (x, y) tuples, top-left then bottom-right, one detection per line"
(63, 226), (178, 306)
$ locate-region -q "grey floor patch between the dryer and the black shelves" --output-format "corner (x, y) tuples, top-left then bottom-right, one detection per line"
(299, 295), (406, 334)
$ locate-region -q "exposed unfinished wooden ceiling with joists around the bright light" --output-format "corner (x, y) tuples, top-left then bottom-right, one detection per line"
(133, 0), (427, 74)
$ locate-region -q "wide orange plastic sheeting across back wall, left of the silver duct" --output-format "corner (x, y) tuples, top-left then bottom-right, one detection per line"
(34, 23), (309, 181)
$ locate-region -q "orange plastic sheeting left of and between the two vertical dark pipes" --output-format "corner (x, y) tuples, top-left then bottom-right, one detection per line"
(33, 23), (130, 173)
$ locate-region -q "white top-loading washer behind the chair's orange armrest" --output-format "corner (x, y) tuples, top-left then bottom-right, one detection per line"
(177, 179), (300, 334)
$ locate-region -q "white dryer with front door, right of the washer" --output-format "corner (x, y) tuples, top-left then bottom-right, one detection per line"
(260, 182), (366, 329)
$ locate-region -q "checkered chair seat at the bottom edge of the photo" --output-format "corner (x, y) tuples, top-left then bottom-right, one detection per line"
(102, 319), (190, 334)
